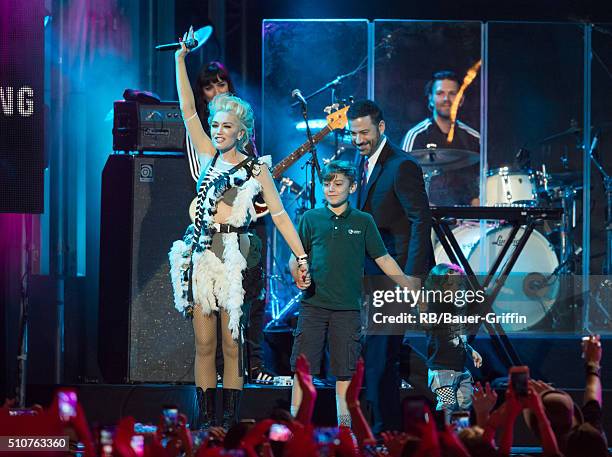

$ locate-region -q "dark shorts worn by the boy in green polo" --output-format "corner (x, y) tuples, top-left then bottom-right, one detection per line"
(291, 304), (361, 381)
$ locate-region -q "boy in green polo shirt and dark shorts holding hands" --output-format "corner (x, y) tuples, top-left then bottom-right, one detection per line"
(289, 161), (413, 426)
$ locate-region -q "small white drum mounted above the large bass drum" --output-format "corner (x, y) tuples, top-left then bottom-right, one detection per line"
(486, 167), (540, 206)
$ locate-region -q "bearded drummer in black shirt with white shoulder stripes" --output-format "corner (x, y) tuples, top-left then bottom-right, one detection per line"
(401, 71), (480, 206)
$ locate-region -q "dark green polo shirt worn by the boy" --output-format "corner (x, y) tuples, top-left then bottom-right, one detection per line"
(298, 206), (387, 310)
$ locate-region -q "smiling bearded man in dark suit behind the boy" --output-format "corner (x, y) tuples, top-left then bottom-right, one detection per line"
(348, 100), (433, 433)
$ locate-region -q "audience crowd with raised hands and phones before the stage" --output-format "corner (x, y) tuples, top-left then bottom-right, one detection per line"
(0, 336), (609, 457)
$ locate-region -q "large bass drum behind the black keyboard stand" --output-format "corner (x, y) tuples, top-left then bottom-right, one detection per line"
(434, 225), (559, 332)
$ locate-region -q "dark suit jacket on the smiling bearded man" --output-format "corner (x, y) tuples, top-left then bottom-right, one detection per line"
(358, 138), (433, 276)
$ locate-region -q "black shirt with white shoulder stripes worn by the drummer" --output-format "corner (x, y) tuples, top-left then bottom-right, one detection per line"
(402, 118), (480, 206)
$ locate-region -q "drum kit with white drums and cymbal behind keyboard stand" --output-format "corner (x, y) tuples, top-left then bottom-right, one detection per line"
(411, 148), (582, 331)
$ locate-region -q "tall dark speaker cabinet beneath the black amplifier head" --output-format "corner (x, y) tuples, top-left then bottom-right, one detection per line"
(98, 155), (195, 383)
